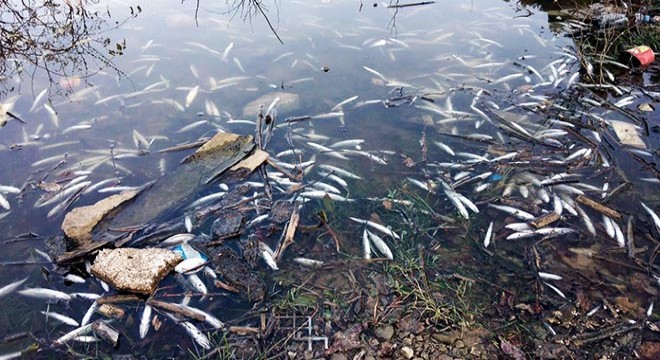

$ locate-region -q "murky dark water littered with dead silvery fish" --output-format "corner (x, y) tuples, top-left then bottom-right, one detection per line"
(0, 0), (659, 357)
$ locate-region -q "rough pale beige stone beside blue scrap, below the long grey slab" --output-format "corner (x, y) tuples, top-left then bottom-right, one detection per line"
(91, 248), (183, 295)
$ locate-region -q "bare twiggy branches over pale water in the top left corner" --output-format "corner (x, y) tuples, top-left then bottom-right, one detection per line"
(0, 0), (141, 97)
